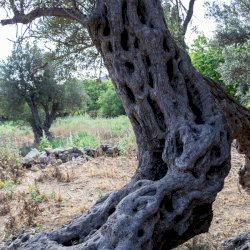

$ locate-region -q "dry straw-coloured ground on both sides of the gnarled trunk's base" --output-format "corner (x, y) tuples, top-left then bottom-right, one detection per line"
(0, 148), (250, 250)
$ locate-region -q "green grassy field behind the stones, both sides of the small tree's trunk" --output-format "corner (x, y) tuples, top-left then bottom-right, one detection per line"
(0, 115), (135, 153)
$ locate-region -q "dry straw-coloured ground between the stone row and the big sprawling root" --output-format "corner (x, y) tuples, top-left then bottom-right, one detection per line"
(0, 157), (137, 244)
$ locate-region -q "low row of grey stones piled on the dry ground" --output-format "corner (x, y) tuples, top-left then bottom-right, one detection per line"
(22, 144), (119, 168)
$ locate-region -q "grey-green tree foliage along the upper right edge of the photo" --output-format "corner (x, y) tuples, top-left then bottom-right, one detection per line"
(207, 0), (250, 106)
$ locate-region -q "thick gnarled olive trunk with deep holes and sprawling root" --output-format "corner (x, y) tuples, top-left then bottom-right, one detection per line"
(1, 0), (250, 250)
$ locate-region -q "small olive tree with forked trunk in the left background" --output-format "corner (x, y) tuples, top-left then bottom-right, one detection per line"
(0, 42), (84, 143)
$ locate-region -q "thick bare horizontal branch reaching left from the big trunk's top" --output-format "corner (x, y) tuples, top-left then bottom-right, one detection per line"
(0, 8), (92, 26)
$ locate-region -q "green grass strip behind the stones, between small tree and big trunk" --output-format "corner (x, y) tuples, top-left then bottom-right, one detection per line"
(42, 115), (135, 154)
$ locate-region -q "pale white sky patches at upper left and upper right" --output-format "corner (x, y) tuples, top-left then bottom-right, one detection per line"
(0, 0), (230, 60)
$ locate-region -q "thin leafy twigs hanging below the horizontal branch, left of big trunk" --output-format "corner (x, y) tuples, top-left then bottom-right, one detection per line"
(27, 15), (99, 77)
